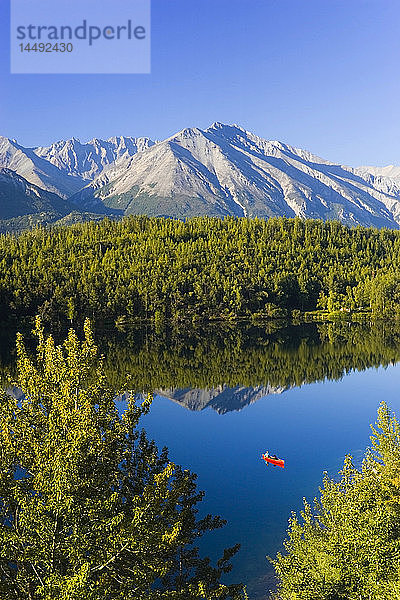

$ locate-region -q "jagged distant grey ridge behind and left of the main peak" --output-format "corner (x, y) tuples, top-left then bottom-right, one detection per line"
(34, 136), (154, 181)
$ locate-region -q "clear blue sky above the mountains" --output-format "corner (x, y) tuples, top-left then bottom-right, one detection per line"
(0, 0), (400, 165)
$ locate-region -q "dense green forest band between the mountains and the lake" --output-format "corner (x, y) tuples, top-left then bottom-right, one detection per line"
(0, 216), (400, 323)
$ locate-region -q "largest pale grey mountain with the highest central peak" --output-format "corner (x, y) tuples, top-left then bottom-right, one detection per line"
(73, 123), (400, 228)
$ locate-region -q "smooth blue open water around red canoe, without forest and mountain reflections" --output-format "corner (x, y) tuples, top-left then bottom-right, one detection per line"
(142, 365), (400, 600)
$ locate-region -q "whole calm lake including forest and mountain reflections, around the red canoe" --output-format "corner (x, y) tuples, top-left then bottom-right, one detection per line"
(3, 323), (400, 600)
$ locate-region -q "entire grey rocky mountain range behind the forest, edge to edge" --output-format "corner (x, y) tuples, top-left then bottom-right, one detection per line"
(0, 123), (400, 230)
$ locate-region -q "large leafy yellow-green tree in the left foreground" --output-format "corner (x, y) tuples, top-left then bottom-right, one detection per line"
(0, 319), (239, 600)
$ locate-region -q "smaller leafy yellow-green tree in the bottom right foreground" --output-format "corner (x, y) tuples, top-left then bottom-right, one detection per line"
(273, 403), (400, 600)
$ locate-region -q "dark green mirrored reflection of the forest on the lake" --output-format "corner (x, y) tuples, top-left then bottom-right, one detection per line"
(0, 321), (400, 392)
